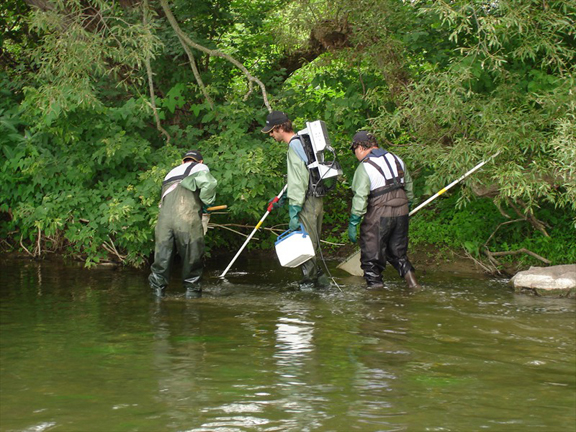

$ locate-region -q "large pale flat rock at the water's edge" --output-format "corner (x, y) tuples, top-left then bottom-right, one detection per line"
(510, 264), (576, 298)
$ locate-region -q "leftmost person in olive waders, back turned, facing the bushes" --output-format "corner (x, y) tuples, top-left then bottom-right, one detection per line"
(148, 150), (217, 297)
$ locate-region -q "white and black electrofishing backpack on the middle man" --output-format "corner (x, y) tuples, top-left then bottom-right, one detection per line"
(298, 120), (342, 197)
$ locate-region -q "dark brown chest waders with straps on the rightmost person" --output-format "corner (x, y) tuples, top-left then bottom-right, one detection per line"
(359, 153), (413, 288)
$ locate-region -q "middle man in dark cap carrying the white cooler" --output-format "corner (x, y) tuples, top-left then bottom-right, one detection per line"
(262, 111), (330, 290)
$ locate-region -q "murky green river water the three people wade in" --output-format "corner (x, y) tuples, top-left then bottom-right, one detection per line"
(0, 253), (576, 432)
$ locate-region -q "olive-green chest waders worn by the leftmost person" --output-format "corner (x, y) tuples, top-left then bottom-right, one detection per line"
(148, 164), (204, 296)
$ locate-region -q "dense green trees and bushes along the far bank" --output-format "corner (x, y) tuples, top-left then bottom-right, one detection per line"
(0, 0), (576, 270)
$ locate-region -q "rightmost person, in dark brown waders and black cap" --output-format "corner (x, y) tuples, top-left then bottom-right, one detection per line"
(348, 131), (418, 289)
